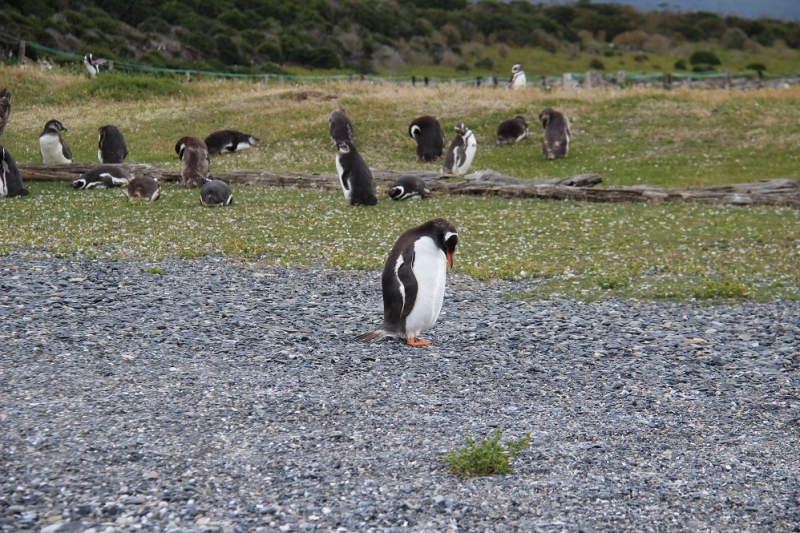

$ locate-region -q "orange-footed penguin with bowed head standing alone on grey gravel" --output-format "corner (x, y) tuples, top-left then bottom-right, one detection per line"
(355, 218), (458, 346)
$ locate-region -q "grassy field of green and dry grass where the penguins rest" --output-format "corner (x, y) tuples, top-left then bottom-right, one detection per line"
(0, 64), (800, 299)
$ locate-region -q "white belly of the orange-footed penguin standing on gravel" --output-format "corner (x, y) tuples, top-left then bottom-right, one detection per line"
(406, 237), (447, 338)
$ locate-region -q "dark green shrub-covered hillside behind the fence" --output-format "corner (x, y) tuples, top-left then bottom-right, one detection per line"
(0, 0), (800, 74)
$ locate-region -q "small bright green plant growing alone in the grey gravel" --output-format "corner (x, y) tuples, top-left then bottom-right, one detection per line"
(441, 428), (531, 479)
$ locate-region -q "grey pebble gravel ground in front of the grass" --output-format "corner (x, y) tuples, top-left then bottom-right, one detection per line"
(0, 255), (800, 532)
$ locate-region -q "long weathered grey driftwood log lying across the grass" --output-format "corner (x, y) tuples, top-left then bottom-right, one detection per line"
(19, 163), (800, 206)
